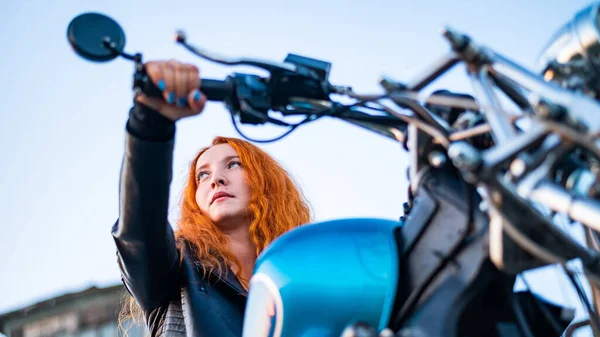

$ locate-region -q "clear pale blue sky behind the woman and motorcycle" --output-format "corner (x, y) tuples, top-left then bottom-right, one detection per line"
(0, 0), (588, 330)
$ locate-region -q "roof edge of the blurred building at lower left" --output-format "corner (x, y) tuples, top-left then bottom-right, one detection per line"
(0, 283), (123, 333)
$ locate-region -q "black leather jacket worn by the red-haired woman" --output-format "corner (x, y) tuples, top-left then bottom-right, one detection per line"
(112, 104), (247, 337)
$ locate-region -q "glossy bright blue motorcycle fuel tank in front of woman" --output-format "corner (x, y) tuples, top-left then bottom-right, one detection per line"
(243, 218), (401, 337)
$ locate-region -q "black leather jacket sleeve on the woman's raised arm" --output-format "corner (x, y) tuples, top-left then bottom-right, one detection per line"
(112, 107), (179, 313)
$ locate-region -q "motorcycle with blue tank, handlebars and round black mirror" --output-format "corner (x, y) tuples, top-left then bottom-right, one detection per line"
(67, 3), (600, 337)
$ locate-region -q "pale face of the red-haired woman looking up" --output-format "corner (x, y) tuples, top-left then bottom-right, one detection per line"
(196, 144), (251, 229)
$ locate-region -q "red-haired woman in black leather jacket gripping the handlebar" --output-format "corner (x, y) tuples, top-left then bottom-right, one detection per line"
(112, 61), (310, 337)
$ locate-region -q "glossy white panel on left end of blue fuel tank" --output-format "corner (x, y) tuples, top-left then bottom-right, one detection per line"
(242, 273), (283, 337)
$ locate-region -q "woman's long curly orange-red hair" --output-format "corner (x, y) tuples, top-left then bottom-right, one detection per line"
(119, 137), (311, 327)
